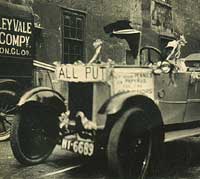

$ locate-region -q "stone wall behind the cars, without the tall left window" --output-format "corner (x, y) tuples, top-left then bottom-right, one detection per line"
(2, 0), (200, 60)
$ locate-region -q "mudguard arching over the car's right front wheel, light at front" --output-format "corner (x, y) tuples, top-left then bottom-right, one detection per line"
(98, 92), (163, 128)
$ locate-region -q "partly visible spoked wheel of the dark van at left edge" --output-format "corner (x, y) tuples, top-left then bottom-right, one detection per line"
(0, 91), (17, 141)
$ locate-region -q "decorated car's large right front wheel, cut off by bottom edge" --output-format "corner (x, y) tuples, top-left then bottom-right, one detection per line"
(107, 108), (153, 179)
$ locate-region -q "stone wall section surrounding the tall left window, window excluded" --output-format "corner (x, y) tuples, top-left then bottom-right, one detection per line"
(33, 0), (145, 62)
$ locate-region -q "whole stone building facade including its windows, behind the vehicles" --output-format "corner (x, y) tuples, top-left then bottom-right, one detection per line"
(1, 0), (200, 96)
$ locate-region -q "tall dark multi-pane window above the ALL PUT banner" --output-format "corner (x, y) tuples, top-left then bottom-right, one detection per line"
(63, 11), (85, 63)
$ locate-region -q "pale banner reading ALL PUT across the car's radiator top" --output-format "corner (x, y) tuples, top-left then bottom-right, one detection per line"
(56, 64), (107, 82)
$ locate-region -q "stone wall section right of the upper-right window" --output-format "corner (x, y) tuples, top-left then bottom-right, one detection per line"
(173, 0), (200, 56)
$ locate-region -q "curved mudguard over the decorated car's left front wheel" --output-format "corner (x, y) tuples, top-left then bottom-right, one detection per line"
(17, 87), (66, 113)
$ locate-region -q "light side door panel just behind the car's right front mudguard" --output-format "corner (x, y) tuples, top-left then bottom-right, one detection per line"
(155, 72), (190, 124)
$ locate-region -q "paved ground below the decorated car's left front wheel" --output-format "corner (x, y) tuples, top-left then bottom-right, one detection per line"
(0, 141), (103, 179)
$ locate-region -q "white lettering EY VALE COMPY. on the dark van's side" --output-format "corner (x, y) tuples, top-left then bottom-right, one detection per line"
(0, 17), (33, 58)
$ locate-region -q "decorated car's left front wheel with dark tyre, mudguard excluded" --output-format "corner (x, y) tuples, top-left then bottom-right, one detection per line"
(11, 105), (57, 165)
